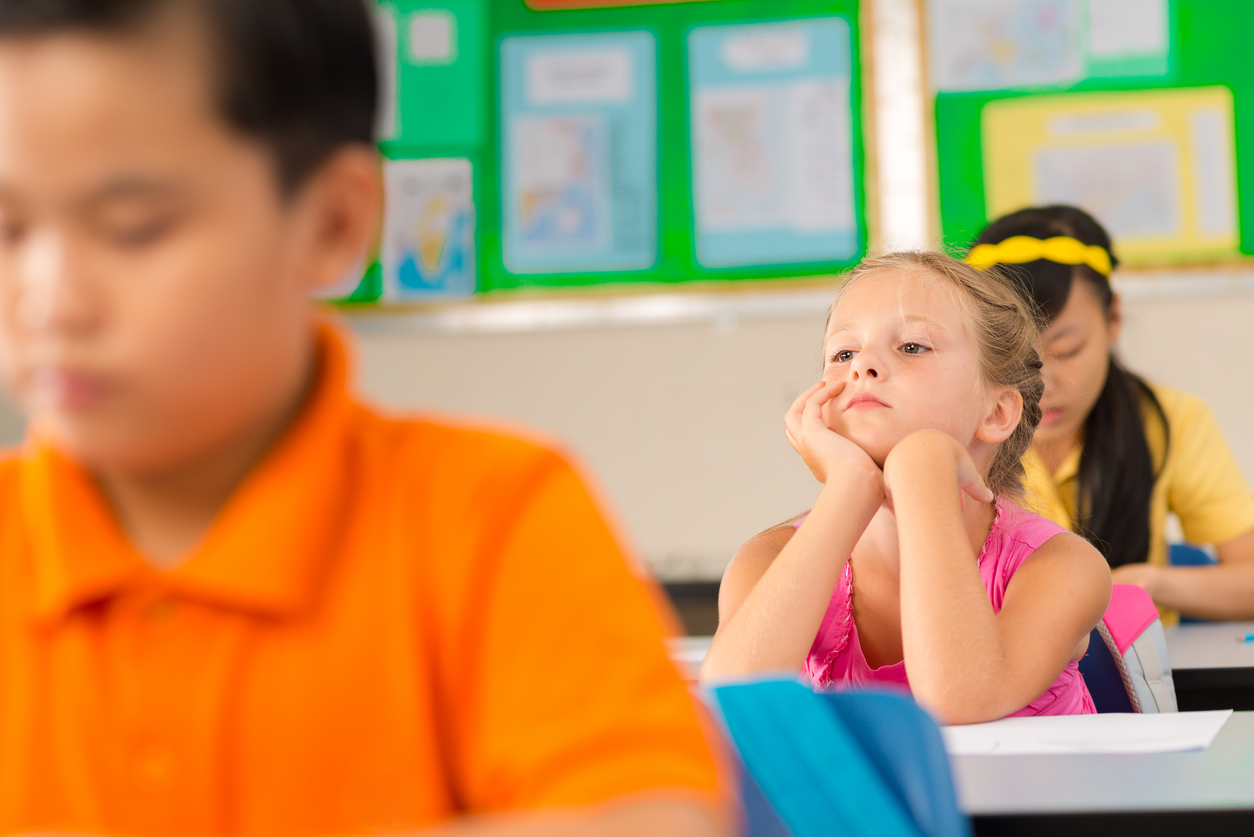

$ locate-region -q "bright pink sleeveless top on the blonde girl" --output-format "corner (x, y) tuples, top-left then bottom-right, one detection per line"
(795, 499), (1097, 717)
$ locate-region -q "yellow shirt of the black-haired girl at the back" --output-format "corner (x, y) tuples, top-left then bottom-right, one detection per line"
(1023, 385), (1254, 622)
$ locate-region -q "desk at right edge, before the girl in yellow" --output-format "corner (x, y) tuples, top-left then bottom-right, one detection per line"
(1166, 622), (1254, 712)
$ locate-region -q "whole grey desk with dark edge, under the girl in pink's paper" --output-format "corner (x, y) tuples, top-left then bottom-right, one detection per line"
(951, 713), (1254, 837)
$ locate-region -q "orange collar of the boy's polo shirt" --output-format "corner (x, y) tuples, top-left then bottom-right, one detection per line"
(21, 324), (354, 621)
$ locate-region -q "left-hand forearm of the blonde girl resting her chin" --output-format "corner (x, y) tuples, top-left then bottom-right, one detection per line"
(701, 479), (880, 680)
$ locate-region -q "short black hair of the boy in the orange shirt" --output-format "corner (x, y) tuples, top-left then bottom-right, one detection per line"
(0, 0), (379, 193)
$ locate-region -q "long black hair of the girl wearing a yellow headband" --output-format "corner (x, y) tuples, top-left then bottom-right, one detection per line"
(976, 206), (1170, 567)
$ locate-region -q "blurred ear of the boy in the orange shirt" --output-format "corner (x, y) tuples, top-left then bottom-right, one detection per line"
(298, 146), (384, 296)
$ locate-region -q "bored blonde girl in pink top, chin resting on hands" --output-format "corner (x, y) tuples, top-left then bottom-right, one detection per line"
(702, 252), (1110, 723)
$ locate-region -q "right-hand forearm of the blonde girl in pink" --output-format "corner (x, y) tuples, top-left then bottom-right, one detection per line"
(893, 458), (1016, 723)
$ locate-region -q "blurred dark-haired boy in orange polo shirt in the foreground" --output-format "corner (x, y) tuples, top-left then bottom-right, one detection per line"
(0, 0), (726, 834)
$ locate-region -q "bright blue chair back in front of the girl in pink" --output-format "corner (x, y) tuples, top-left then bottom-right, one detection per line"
(711, 680), (971, 837)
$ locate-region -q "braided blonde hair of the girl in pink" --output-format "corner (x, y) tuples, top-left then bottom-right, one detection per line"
(828, 251), (1045, 496)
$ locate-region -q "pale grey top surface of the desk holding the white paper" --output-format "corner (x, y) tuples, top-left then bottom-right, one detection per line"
(951, 713), (1254, 816)
